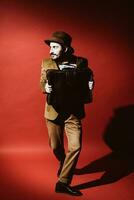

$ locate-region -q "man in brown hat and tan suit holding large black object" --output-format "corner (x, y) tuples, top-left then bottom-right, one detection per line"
(40, 31), (93, 196)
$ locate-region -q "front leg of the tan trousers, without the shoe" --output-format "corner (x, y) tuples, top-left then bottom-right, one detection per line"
(59, 115), (82, 184)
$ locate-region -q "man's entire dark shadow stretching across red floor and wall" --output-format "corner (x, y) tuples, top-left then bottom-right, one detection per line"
(74, 105), (134, 189)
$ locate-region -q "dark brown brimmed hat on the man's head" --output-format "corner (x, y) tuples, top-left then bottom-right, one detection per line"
(44, 31), (72, 47)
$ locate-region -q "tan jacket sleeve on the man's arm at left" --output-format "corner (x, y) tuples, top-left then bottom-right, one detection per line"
(40, 60), (47, 93)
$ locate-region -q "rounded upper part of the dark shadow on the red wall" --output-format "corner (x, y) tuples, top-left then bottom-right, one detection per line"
(104, 105), (134, 157)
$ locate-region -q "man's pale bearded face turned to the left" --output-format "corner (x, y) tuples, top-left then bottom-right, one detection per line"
(50, 42), (63, 60)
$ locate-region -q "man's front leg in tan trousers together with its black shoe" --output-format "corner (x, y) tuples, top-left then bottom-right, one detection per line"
(55, 115), (82, 196)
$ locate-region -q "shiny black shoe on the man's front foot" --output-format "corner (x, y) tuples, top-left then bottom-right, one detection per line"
(55, 181), (82, 196)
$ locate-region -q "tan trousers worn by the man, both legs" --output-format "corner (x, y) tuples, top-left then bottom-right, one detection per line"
(46, 115), (82, 184)
